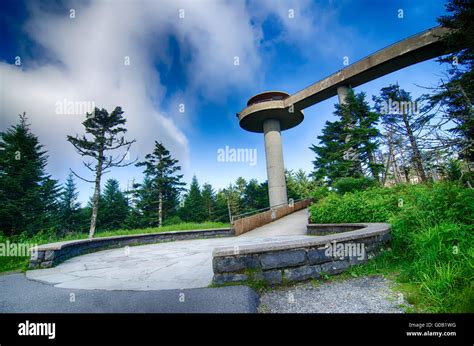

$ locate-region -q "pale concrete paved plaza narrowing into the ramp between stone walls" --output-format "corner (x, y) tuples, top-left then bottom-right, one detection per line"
(26, 210), (307, 291)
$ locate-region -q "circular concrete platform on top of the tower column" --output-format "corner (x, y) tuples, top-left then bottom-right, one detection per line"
(238, 91), (304, 133)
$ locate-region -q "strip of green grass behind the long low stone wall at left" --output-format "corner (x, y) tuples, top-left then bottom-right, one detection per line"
(0, 222), (230, 273)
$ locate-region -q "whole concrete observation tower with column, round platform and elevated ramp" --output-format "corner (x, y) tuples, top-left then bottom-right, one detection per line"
(237, 26), (448, 207)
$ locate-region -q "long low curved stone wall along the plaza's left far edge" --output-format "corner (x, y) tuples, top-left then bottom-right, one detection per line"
(29, 228), (235, 269)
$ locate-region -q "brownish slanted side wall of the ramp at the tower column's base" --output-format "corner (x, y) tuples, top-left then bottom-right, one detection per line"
(232, 198), (312, 236)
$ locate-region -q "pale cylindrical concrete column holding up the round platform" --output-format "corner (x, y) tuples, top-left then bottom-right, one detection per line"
(263, 119), (288, 207)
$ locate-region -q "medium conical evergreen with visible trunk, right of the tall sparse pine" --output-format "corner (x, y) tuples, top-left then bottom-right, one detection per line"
(136, 141), (185, 227)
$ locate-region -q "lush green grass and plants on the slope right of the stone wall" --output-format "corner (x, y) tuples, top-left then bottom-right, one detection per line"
(311, 183), (474, 312)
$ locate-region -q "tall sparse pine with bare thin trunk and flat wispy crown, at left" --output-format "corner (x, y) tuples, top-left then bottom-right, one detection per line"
(67, 107), (135, 238)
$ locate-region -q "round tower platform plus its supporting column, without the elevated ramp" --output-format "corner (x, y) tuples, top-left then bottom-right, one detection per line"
(239, 91), (304, 207)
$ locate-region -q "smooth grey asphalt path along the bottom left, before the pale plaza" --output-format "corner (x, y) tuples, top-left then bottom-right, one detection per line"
(0, 273), (259, 313)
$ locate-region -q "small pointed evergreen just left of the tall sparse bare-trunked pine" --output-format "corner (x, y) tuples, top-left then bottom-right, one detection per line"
(59, 173), (81, 233)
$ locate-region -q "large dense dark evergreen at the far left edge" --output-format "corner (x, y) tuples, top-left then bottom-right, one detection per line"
(0, 113), (58, 236)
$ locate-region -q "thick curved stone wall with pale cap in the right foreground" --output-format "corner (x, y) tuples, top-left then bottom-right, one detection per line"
(212, 223), (390, 285)
